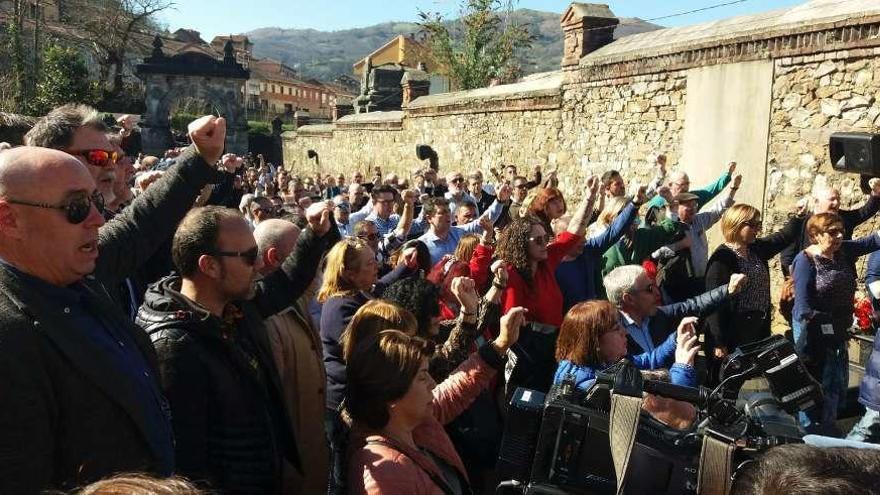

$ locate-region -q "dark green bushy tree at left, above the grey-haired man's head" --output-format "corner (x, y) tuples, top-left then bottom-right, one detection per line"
(34, 45), (95, 115)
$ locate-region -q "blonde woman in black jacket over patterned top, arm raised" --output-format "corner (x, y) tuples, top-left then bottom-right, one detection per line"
(704, 204), (797, 383)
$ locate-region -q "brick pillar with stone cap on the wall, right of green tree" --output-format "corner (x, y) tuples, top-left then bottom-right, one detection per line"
(560, 3), (620, 68)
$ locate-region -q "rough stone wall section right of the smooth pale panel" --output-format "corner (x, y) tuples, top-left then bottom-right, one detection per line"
(765, 48), (880, 280)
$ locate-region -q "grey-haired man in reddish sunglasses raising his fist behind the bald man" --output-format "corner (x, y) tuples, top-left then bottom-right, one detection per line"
(25, 105), (234, 320)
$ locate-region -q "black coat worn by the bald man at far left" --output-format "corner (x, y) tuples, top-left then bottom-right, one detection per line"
(0, 268), (172, 494)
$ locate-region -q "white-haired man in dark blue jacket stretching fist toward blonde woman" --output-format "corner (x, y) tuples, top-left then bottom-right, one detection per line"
(603, 265), (746, 354)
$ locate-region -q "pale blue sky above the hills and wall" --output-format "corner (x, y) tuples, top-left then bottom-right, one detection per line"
(162, 0), (806, 41)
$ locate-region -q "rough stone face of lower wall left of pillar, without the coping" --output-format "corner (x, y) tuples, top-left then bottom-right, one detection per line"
(284, 94), (570, 185)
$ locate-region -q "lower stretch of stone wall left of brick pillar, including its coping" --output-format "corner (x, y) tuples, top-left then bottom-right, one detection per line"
(284, 74), (571, 181)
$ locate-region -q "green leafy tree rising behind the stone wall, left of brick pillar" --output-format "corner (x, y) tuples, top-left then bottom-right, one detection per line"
(419, 0), (535, 89)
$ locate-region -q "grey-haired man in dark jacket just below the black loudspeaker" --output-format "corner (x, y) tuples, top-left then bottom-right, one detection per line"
(779, 179), (880, 277)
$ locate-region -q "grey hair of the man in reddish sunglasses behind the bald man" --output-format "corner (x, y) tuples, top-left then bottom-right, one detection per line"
(24, 103), (107, 150)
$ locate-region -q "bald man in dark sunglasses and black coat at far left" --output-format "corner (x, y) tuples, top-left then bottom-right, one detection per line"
(0, 147), (174, 493)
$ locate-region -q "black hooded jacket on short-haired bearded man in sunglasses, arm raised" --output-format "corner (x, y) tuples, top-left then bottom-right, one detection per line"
(137, 226), (339, 494)
